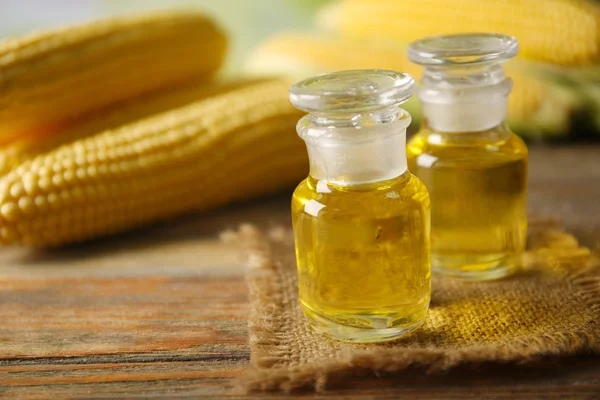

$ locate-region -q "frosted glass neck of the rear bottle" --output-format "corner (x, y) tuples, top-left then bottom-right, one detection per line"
(417, 65), (512, 133)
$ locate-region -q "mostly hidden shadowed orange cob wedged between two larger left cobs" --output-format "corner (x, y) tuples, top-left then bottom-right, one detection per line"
(0, 80), (262, 176)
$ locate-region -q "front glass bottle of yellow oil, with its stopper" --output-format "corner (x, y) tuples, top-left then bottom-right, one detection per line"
(290, 70), (430, 342)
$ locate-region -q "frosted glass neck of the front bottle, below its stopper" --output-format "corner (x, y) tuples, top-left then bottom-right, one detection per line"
(298, 107), (411, 186)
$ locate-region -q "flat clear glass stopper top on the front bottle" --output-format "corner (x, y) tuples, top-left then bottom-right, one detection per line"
(290, 69), (415, 113)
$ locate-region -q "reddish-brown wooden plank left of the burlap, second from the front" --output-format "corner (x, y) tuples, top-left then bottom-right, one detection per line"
(0, 276), (247, 359)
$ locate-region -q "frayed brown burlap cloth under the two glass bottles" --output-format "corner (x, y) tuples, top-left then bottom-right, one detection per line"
(224, 220), (600, 391)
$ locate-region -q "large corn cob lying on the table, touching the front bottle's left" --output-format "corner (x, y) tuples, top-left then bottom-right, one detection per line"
(0, 80), (307, 246)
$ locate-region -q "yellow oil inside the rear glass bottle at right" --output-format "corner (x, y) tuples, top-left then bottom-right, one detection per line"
(407, 127), (527, 280)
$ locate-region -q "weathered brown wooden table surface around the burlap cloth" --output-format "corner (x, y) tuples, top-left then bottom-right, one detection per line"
(0, 145), (600, 399)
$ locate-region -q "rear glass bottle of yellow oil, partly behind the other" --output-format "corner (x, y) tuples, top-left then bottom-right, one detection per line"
(407, 34), (527, 280)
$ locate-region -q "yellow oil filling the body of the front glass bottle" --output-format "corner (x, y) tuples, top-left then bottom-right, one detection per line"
(292, 171), (430, 342)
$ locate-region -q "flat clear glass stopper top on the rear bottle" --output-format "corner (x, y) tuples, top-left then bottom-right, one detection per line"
(408, 33), (519, 67)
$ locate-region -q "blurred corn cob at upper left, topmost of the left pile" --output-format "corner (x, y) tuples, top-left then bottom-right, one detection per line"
(0, 12), (226, 145)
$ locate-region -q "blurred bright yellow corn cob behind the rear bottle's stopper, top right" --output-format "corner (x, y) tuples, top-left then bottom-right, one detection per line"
(318, 0), (600, 65)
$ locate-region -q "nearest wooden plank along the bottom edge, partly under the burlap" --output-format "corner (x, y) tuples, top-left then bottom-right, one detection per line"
(0, 358), (600, 399)
